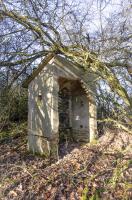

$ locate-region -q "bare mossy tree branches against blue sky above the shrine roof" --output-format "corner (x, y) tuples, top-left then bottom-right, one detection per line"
(0, 0), (131, 128)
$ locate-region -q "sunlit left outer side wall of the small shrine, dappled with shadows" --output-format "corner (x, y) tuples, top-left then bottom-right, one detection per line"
(28, 64), (58, 156)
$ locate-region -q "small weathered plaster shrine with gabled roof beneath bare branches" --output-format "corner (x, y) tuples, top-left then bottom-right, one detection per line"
(24, 54), (97, 157)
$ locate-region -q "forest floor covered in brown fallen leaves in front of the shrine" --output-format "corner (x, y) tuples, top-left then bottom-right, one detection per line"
(0, 124), (132, 200)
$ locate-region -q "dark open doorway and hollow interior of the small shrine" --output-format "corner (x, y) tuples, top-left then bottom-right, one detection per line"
(58, 78), (88, 157)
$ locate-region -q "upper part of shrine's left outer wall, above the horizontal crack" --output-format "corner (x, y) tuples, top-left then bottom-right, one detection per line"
(28, 66), (53, 137)
